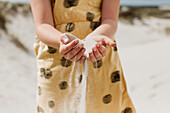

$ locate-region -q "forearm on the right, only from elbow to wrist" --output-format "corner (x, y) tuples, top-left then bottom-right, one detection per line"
(87, 19), (117, 38)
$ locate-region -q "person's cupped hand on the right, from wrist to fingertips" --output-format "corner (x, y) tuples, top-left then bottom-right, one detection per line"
(87, 35), (116, 62)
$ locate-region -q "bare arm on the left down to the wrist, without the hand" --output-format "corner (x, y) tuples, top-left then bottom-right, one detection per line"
(30, 0), (62, 48)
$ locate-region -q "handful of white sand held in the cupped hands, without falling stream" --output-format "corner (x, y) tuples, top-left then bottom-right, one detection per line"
(63, 33), (97, 58)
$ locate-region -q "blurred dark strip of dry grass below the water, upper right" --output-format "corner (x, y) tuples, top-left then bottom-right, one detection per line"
(119, 6), (170, 24)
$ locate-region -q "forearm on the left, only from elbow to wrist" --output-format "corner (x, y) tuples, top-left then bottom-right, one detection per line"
(36, 24), (62, 48)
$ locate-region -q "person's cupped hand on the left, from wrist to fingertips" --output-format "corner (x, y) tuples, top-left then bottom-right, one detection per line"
(59, 35), (86, 63)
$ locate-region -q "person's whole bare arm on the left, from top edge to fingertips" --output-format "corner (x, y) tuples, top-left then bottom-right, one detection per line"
(30, 0), (85, 63)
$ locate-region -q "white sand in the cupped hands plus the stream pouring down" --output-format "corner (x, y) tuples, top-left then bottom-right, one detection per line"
(61, 33), (97, 113)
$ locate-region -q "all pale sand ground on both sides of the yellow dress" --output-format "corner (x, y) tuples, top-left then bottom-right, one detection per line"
(0, 9), (170, 113)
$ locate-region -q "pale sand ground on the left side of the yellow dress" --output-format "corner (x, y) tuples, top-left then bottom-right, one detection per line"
(0, 12), (37, 113)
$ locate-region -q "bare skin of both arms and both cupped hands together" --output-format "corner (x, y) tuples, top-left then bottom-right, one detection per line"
(30, 0), (120, 63)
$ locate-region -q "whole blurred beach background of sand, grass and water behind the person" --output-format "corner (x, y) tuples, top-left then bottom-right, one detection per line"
(0, 0), (170, 113)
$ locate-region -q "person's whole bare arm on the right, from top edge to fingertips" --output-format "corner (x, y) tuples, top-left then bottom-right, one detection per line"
(87, 0), (120, 62)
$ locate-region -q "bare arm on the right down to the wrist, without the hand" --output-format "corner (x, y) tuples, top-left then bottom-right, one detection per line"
(87, 0), (120, 38)
